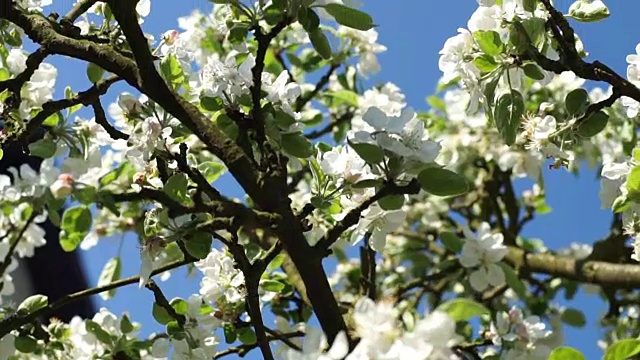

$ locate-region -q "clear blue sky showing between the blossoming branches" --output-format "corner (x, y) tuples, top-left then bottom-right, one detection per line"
(38, 0), (640, 359)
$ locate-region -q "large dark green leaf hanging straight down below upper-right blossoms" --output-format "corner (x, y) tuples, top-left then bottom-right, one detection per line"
(494, 90), (524, 146)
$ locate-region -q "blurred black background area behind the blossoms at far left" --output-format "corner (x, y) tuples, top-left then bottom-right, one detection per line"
(0, 131), (96, 322)
